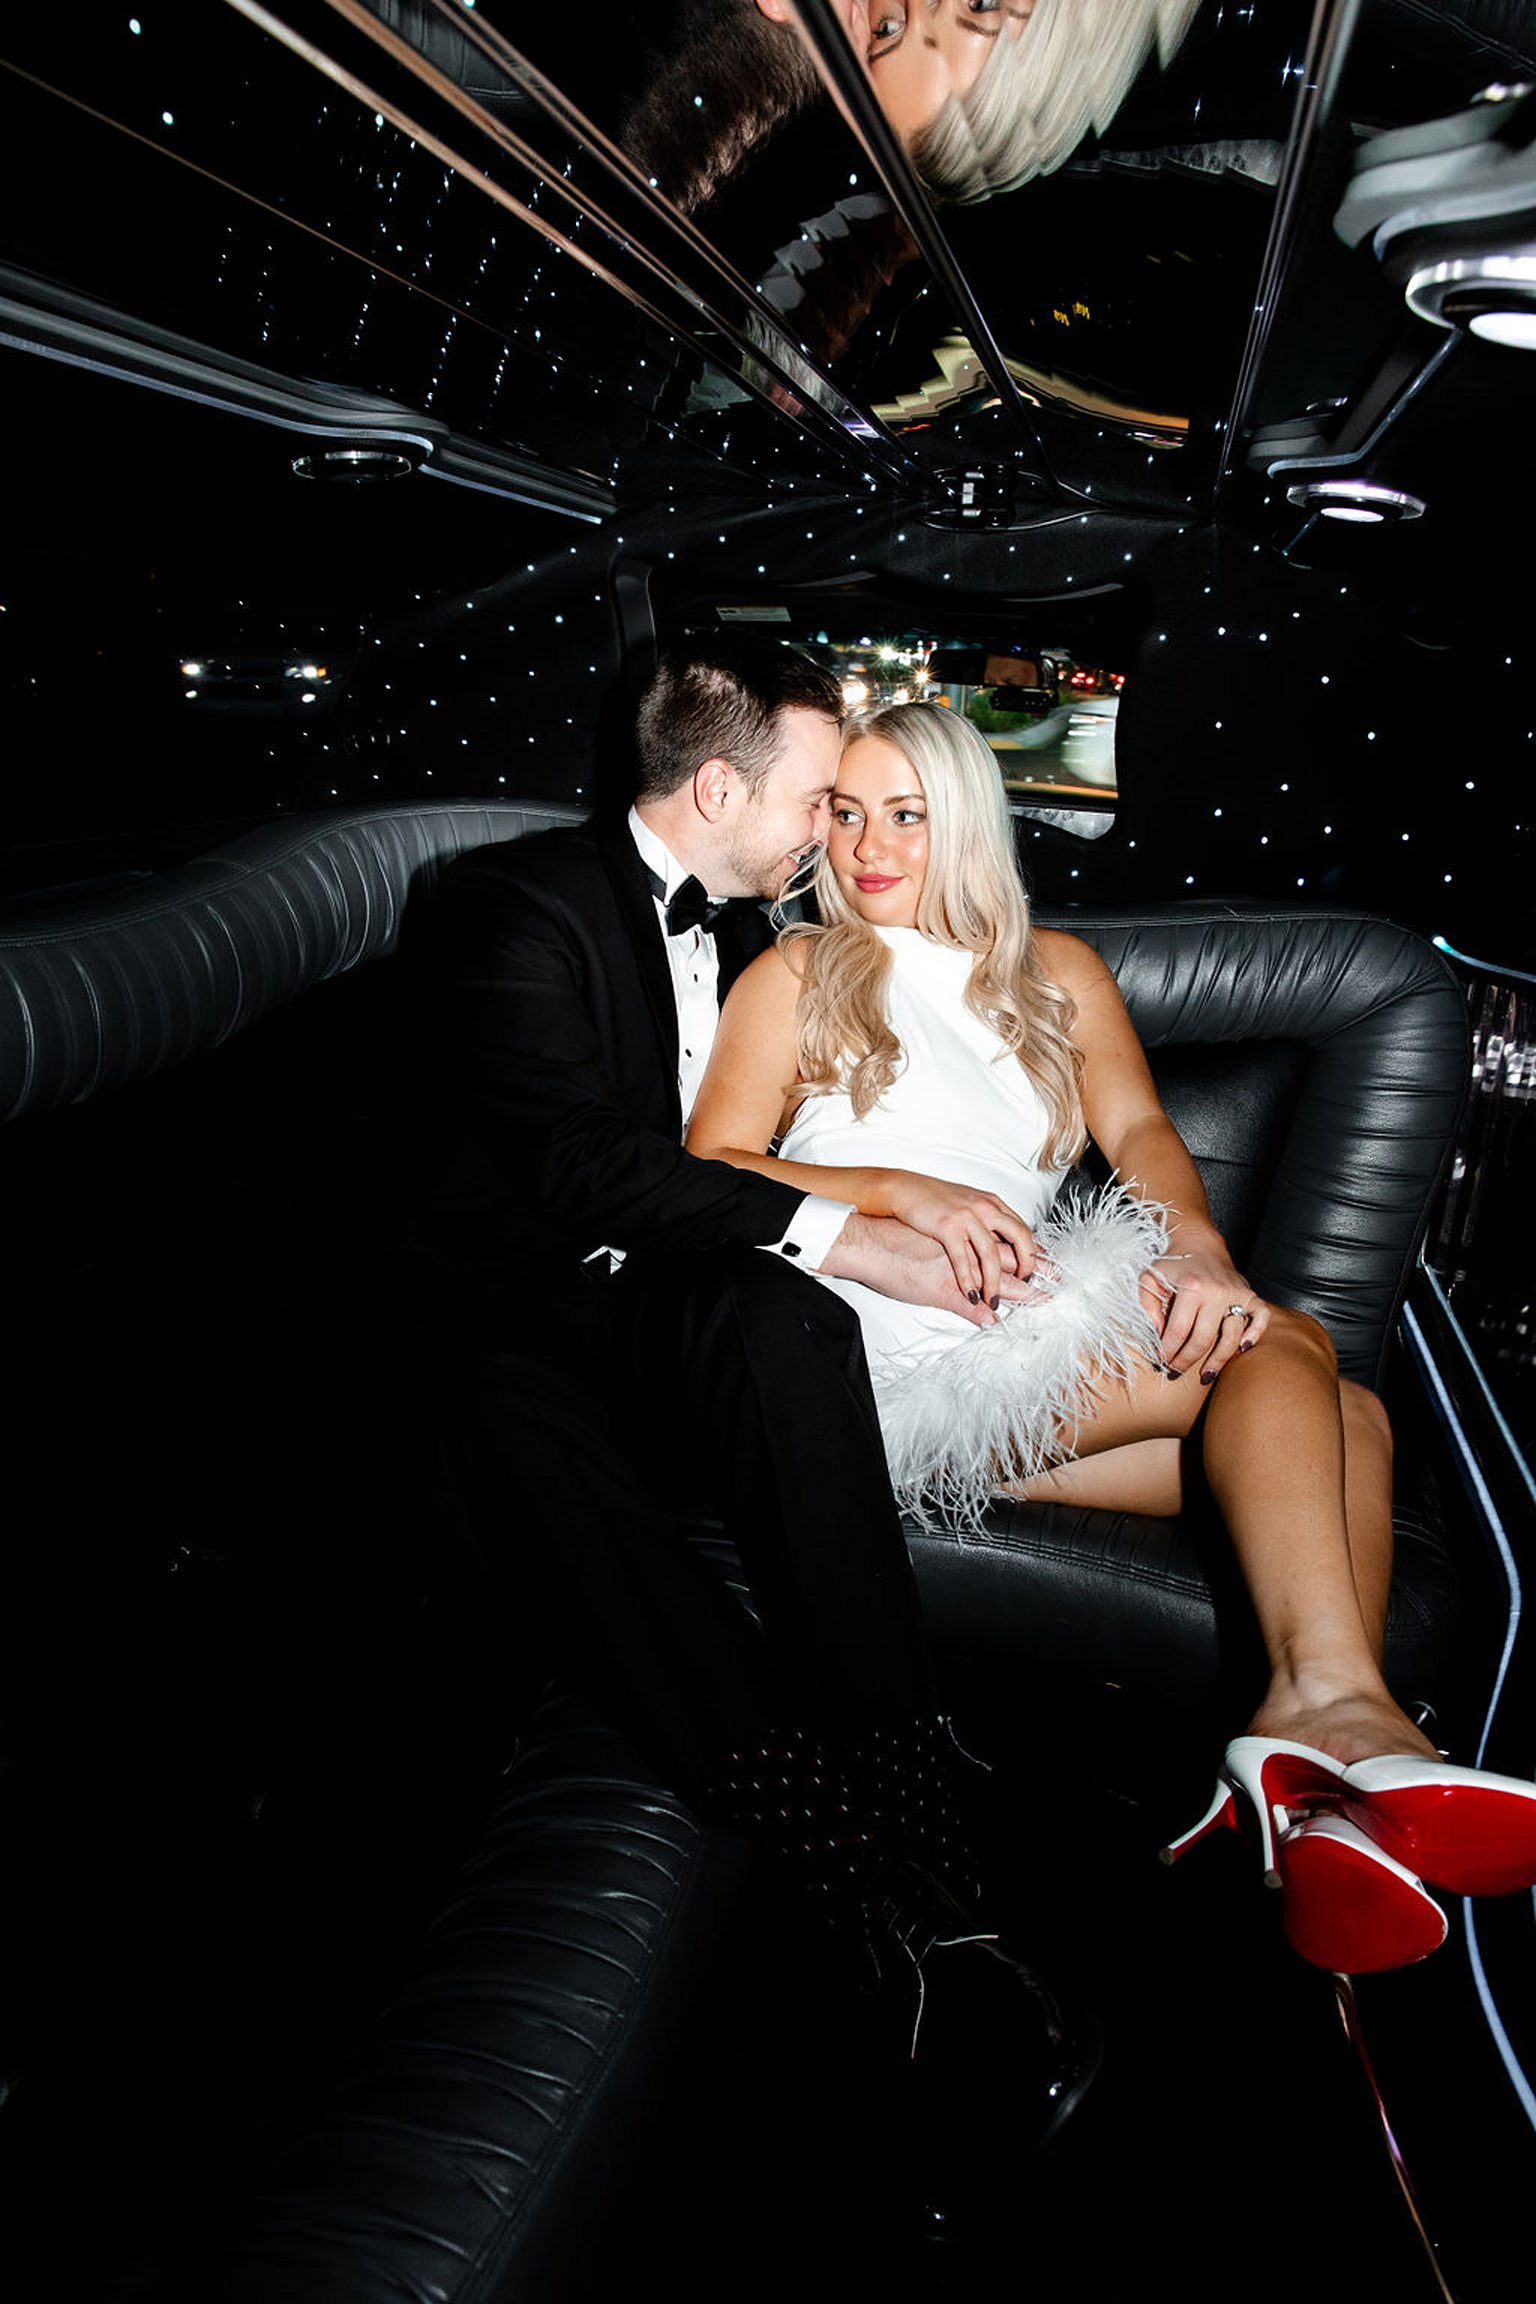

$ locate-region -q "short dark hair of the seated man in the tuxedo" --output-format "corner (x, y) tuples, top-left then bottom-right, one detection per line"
(636, 634), (843, 799)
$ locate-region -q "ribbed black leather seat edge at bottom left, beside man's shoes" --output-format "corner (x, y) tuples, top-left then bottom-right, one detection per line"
(173, 1700), (746, 2304)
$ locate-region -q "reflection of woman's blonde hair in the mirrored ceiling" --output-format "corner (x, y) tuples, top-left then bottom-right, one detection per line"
(912, 0), (1200, 203)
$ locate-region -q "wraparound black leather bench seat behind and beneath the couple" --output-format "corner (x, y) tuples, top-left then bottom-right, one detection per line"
(0, 802), (1469, 1707)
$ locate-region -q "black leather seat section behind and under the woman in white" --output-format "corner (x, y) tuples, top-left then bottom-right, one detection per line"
(912, 903), (1469, 1716)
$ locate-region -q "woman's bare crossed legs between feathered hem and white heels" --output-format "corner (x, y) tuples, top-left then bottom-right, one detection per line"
(1004, 1311), (1432, 1760)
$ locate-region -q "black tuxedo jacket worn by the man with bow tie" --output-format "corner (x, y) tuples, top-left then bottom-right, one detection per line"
(414, 820), (801, 1288)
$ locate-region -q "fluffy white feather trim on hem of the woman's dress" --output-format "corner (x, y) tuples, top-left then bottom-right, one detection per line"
(870, 1184), (1168, 1528)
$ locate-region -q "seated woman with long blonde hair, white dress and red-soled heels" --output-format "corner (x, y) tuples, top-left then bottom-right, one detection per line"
(689, 705), (1536, 1972)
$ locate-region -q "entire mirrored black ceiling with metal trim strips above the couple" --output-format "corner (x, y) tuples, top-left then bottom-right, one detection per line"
(0, 0), (1529, 548)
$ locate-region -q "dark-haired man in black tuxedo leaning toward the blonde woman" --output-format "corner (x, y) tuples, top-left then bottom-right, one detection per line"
(416, 636), (1087, 2211)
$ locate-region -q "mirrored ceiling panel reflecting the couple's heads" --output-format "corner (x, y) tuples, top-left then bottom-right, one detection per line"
(499, 0), (1313, 509)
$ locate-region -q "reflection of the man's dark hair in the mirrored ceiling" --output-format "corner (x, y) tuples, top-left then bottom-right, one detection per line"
(619, 0), (822, 214)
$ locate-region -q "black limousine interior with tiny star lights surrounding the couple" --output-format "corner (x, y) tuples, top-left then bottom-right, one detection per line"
(0, 0), (1536, 2304)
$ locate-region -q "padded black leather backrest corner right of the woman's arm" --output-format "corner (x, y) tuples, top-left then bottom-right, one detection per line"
(1041, 905), (1472, 1389)
